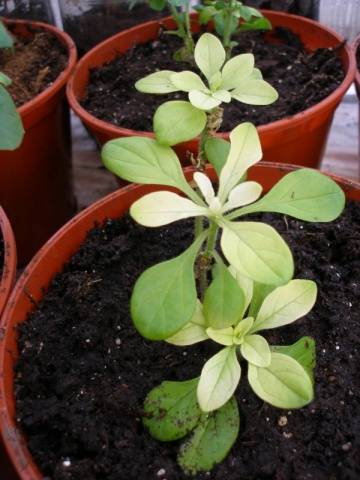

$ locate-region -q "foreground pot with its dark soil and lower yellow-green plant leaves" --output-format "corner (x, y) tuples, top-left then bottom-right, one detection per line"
(0, 32), (359, 479)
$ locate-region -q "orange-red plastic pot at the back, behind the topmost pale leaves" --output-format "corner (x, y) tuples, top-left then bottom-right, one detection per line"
(67, 10), (355, 168)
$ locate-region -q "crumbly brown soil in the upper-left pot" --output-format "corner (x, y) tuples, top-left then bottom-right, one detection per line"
(0, 28), (68, 107)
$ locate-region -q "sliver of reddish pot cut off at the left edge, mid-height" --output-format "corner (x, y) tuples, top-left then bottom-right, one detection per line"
(0, 205), (17, 319)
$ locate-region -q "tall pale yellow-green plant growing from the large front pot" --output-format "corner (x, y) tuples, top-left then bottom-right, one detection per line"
(102, 34), (345, 475)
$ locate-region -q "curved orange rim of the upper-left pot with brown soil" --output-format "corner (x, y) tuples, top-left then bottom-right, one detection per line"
(3, 18), (77, 118)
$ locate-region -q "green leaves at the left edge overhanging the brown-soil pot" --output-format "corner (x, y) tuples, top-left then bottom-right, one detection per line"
(0, 21), (24, 150)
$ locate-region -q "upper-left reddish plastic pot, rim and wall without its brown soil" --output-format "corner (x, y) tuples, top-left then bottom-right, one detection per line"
(0, 20), (76, 264)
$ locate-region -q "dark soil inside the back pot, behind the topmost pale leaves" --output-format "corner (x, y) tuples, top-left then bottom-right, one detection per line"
(82, 28), (344, 131)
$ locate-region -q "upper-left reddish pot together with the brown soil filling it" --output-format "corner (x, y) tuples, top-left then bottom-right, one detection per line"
(0, 20), (76, 264)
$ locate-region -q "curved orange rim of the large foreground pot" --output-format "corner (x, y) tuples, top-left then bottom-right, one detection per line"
(0, 162), (360, 480)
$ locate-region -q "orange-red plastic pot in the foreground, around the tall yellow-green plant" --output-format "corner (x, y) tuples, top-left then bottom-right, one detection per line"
(0, 163), (360, 480)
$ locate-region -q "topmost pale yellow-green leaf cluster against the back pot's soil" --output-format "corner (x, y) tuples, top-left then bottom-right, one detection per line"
(135, 33), (278, 164)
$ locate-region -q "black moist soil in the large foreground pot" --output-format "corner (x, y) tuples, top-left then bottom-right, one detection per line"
(16, 203), (360, 480)
